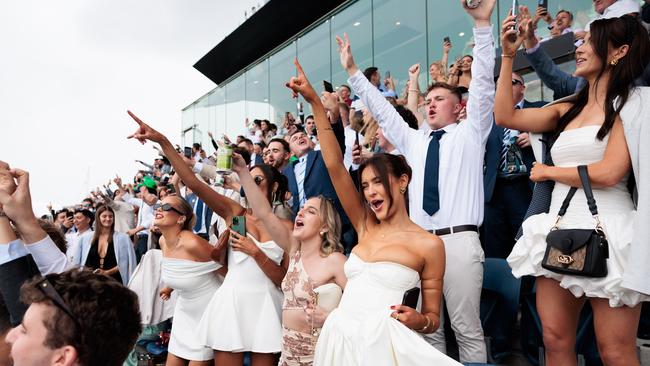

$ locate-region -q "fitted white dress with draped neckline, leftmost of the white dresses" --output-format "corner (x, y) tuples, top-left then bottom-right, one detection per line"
(162, 257), (221, 361)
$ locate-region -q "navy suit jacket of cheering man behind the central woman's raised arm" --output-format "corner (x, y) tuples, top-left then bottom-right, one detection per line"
(282, 120), (350, 224)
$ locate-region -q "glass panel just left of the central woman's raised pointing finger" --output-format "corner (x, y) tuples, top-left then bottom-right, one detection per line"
(269, 42), (296, 128)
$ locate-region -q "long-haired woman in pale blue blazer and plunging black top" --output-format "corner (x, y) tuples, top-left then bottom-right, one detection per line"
(73, 206), (137, 286)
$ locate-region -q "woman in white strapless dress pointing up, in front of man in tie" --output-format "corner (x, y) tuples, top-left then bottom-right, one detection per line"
(287, 58), (459, 366)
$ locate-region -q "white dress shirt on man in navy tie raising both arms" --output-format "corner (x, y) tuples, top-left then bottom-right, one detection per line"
(348, 27), (495, 230)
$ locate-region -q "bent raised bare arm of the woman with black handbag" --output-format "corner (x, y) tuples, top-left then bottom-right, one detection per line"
(494, 15), (563, 132)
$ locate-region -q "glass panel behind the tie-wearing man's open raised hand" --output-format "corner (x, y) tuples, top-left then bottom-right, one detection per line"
(330, 0), (372, 92)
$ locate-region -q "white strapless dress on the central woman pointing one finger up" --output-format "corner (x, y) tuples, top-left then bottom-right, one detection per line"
(314, 253), (460, 366)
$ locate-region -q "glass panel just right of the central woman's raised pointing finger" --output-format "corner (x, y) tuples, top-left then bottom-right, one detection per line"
(298, 20), (331, 114)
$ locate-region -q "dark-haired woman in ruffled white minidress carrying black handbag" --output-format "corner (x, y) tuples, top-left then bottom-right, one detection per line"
(495, 12), (650, 366)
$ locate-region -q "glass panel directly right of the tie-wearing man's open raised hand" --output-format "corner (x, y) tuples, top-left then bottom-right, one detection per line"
(370, 0), (426, 95)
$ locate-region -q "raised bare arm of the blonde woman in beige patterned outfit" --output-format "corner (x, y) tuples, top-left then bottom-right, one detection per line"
(232, 153), (298, 253)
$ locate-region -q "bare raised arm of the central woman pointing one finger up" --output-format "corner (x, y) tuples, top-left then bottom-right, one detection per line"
(287, 60), (366, 232)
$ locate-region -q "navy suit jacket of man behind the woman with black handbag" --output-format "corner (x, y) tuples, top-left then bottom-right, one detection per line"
(483, 100), (546, 202)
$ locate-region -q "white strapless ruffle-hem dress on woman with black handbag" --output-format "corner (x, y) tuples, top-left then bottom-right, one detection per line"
(508, 126), (650, 307)
